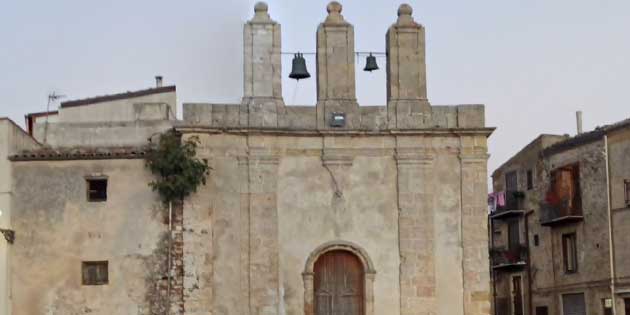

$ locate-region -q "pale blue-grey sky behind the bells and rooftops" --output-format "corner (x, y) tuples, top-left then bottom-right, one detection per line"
(0, 0), (630, 177)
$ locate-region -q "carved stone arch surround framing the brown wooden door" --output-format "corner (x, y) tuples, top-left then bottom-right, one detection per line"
(302, 241), (376, 315)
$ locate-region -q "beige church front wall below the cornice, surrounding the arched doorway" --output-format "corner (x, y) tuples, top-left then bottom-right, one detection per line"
(185, 128), (489, 314)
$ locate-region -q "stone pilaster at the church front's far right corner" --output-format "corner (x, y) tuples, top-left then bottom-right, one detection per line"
(460, 137), (490, 315)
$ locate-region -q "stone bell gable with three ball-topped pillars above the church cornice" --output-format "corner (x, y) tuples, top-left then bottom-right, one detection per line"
(184, 1), (485, 131)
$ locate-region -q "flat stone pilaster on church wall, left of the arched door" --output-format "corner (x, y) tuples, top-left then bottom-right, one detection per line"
(248, 149), (280, 315)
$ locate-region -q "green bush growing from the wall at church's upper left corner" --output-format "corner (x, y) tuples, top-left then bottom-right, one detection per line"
(146, 129), (210, 203)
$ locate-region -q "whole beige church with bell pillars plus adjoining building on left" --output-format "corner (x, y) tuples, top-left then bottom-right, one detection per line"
(0, 2), (493, 315)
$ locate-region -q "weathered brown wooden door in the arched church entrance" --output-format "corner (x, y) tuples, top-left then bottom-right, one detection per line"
(314, 250), (365, 315)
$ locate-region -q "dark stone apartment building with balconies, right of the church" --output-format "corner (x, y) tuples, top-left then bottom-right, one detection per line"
(490, 120), (630, 315)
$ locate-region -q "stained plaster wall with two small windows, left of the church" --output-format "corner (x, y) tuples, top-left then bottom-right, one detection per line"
(11, 160), (173, 315)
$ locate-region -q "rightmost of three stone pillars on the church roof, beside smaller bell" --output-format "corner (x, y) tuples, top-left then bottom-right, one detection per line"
(386, 4), (431, 129)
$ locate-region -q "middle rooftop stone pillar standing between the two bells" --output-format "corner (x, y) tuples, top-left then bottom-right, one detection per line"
(317, 1), (361, 129)
